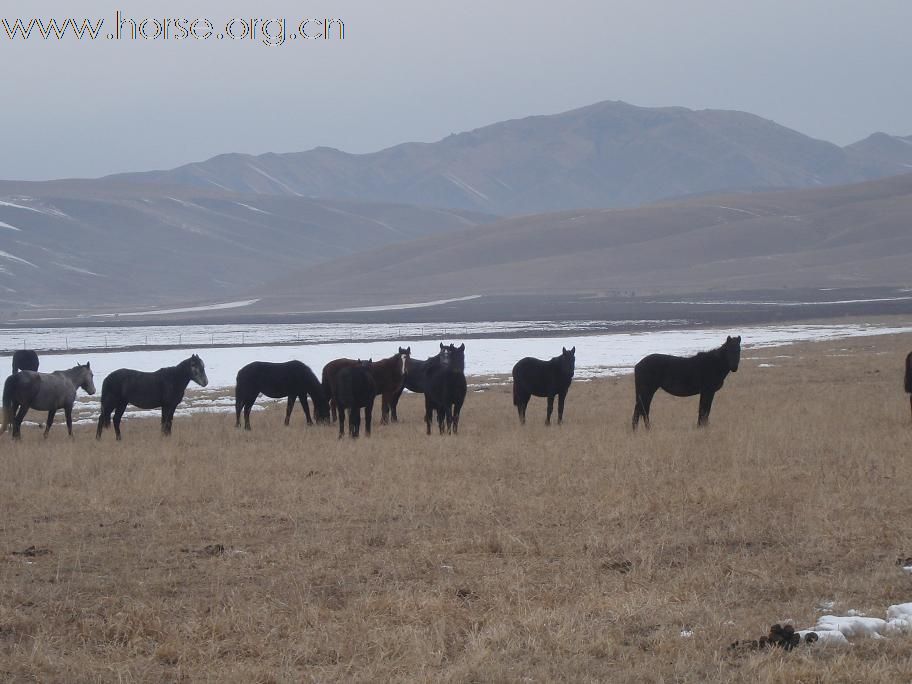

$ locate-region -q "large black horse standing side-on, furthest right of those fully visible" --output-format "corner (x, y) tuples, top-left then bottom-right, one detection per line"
(633, 335), (741, 430)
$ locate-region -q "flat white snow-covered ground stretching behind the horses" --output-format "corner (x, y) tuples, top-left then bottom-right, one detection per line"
(0, 324), (912, 418)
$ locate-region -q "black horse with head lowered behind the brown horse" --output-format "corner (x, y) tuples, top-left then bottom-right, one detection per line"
(234, 361), (329, 430)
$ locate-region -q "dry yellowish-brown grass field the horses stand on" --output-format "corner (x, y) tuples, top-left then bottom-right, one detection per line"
(0, 336), (912, 682)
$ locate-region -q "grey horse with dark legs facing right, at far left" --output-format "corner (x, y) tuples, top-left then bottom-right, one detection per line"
(0, 364), (95, 439)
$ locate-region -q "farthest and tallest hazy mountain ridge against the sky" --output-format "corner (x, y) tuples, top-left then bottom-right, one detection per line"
(116, 102), (912, 215)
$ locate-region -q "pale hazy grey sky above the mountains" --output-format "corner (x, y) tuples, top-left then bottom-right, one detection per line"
(0, 0), (912, 179)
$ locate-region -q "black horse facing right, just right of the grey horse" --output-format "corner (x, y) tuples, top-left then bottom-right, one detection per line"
(95, 354), (209, 439)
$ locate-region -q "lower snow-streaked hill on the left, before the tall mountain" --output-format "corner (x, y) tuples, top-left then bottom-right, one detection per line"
(0, 180), (488, 318)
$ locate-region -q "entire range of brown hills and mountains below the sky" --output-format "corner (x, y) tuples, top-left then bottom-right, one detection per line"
(0, 102), (912, 320)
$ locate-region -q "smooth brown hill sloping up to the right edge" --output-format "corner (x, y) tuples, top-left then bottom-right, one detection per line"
(256, 175), (912, 310)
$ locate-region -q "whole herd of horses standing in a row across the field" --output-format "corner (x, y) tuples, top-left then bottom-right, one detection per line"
(0, 336), (912, 440)
